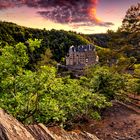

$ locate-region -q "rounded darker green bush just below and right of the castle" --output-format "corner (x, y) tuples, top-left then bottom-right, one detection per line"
(81, 66), (125, 100)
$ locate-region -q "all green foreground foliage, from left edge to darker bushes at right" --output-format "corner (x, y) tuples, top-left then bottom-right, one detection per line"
(0, 40), (140, 126)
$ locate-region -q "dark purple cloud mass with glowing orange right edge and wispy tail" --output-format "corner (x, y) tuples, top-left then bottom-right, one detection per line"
(0, 0), (113, 28)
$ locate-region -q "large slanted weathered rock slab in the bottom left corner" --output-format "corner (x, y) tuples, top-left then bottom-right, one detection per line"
(0, 109), (34, 140)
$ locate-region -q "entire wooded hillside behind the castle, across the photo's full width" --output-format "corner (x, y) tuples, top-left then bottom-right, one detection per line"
(0, 22), (140, 69)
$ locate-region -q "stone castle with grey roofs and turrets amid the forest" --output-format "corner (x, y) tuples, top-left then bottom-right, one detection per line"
(66, 45), (99, 69)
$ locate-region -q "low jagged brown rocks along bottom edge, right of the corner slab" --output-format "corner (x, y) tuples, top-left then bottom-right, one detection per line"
(26, 124), (99, 140)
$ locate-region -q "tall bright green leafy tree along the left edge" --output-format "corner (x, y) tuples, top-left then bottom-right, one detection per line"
(0, 40), (40, 118)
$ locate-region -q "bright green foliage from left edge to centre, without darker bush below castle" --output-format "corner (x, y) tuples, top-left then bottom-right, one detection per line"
(0, 40), (110, 124)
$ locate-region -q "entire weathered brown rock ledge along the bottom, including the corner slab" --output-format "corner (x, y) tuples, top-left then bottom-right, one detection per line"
(0, 109), (99, 140)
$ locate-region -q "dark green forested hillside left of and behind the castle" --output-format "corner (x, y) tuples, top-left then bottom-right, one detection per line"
(0, 21), (91, 68)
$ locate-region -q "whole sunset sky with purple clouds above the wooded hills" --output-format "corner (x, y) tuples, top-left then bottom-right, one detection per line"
(0, 0), (140, 34)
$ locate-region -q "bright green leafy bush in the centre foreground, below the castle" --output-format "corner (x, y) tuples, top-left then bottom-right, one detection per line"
(34, 75), (108, 123)
